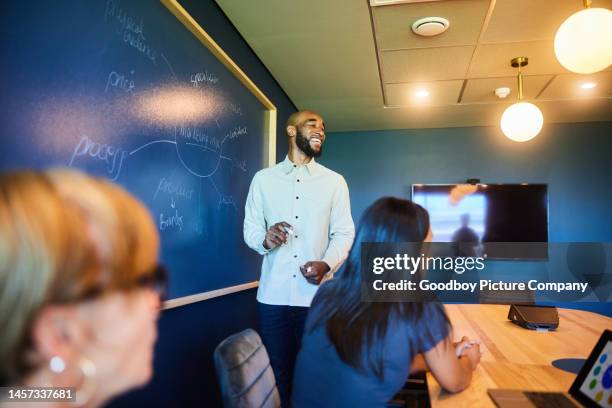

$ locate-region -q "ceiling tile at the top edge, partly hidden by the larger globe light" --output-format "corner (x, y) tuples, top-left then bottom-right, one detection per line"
(482, 0), (612, 43)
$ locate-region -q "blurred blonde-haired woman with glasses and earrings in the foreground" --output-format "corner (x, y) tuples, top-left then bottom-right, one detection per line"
(0, 171), (164, 407)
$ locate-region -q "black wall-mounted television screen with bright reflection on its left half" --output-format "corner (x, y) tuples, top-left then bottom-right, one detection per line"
(412, 184), (548, 259)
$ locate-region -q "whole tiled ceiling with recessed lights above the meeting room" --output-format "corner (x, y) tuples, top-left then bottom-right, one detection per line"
(217, 0), (612, 131)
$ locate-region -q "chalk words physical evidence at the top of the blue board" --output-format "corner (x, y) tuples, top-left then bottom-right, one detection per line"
(104, 0), (157, 65)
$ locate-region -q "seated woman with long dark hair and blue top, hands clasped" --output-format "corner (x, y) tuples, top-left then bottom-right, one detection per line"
(292, 197), (480, 408)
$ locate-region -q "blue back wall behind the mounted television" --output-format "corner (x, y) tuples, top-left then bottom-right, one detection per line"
(321, 122), (612, 316)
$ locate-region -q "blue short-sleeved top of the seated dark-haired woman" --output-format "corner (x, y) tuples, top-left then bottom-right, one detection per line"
(292, 281), (448, 408)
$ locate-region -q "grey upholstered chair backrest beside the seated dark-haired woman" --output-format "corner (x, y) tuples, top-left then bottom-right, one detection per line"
(214, 329), (280, 408)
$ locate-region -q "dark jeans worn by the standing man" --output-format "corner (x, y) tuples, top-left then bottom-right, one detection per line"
(257, 302), (308, 407)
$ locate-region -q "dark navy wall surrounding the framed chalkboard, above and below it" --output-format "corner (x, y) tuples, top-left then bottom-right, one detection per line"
(110, 0), (296, 408)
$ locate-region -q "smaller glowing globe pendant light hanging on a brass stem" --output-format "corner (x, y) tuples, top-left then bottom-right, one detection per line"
(501, 57), (544, 142)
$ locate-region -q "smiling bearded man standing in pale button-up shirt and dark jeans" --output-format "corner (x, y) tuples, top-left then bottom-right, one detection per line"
(244, 110), (355, 407)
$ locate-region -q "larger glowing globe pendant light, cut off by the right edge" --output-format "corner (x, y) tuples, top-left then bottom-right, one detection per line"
(555, 0), (612, 74)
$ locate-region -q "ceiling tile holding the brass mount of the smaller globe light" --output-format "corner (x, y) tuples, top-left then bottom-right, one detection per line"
(468, 41), (568, 78)
